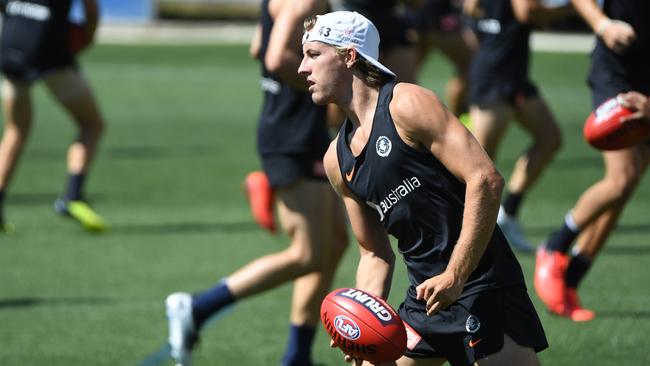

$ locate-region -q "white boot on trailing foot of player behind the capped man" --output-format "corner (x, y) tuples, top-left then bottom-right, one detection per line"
(165, 292), (197, 366)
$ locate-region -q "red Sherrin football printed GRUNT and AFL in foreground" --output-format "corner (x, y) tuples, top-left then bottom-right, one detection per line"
(320, 288), (406, 363)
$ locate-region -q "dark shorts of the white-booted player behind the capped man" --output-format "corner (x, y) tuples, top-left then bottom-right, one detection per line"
(262, 153), (327, 188)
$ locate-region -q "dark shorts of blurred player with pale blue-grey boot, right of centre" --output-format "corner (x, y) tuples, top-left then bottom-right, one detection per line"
(469, 77), (539, 107)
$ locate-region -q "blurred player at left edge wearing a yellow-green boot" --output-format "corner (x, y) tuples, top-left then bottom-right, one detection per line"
(0, 0), (107, 231)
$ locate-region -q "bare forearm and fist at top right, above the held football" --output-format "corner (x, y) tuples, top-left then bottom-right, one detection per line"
(571, 0), (636, 53)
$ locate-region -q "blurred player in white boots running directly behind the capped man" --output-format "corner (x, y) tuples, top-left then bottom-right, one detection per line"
(166, 0), (347, 366)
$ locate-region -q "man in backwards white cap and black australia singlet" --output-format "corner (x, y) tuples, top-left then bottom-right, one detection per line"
(300, 11), (547, 366)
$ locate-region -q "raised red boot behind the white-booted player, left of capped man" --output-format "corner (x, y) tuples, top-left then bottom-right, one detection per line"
(244, 171), (277, 234)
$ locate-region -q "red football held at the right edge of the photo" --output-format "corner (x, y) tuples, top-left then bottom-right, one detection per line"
(583, 98), (650, 150)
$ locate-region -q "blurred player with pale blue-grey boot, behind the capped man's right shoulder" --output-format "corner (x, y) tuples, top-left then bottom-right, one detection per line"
(465, 0), (573, 252)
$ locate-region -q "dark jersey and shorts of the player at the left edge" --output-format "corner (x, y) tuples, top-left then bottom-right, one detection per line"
(0, 0), (74, 77)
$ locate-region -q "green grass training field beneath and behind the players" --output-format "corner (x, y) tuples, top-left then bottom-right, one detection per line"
(0, 46), (650, 366)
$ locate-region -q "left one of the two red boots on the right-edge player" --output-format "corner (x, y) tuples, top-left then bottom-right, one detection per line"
(535, 245), (569, 314)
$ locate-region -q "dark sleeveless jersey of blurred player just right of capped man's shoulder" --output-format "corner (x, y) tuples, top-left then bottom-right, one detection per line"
(471, 0), (531, 81)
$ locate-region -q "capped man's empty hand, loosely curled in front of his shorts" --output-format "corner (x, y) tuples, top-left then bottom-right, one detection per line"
(415, 271), (465, 315)
